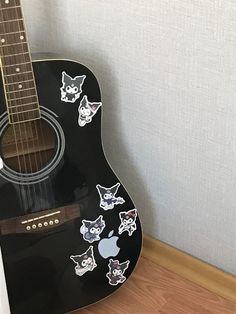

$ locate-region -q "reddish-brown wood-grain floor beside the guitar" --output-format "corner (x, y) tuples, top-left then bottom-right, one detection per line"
(73, 257), (236, 314)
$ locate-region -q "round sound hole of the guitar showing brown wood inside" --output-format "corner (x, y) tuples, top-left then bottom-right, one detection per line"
(1, 119), (57, 174)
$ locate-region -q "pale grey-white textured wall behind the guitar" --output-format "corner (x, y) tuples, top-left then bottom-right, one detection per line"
(23, 0), (236, 273)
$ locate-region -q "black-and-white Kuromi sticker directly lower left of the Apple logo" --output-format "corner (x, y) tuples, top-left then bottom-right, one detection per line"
(70, 245), (97, 276)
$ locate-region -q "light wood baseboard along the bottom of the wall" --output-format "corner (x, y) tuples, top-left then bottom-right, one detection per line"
(142, 234), (236, 303)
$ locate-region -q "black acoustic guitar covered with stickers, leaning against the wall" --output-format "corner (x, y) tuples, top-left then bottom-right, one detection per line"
(0, 0), (142, 314)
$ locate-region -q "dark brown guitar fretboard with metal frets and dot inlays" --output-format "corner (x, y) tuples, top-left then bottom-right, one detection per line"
(0, 0), (40, 124)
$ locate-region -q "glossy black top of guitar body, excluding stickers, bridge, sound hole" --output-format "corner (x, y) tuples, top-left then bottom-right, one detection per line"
(0, 60), (142, 314)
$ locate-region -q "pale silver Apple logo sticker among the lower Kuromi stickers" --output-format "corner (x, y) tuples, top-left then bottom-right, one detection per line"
(98, 230), (120, 258)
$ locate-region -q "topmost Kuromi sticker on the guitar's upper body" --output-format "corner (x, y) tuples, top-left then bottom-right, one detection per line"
(61, 72), (86, 103)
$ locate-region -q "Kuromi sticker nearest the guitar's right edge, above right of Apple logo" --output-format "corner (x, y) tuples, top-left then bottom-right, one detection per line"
(118, 208), (137, 236)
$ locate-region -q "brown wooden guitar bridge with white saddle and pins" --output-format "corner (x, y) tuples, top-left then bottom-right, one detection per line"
(0, 204), (80, 235)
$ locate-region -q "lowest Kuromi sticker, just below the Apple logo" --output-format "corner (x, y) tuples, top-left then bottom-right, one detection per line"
(106, 259), (130, 286)
